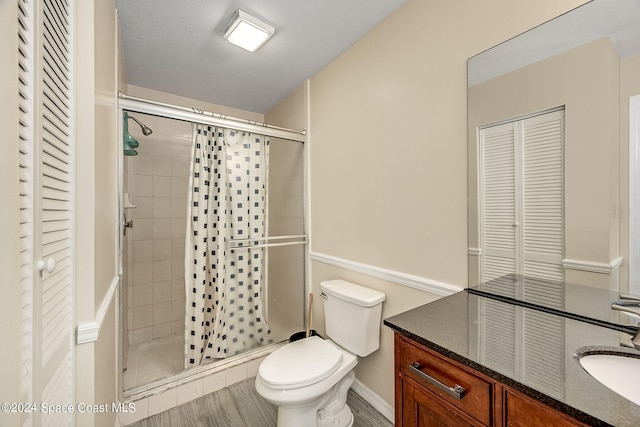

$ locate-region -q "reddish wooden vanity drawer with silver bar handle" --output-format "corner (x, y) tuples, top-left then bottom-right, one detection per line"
(399, 338), (493, 425)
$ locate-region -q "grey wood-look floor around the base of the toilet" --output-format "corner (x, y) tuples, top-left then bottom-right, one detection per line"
(130, 378), (393, 427)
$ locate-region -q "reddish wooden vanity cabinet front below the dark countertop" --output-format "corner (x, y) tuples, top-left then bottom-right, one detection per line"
(394, 332), (586, 427)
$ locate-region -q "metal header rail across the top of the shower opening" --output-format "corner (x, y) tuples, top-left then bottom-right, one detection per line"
(118, 92), (307, 143)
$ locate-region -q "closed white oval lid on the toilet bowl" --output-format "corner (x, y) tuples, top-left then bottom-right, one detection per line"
(258, 336), (342, 388)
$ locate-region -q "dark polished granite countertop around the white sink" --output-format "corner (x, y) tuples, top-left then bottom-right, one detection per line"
(384, 291), (640, 426)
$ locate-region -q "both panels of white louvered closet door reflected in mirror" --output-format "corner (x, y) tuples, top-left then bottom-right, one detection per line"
(479, 110), (564, 281)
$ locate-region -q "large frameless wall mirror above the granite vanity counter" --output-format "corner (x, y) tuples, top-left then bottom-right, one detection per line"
(468, 0), (640, 293)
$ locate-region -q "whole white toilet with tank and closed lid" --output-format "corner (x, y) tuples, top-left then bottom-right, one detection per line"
(256, 280), (385, 427)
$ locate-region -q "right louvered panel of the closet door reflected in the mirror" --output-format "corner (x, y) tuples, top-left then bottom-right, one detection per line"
(521, 111), (564, 280)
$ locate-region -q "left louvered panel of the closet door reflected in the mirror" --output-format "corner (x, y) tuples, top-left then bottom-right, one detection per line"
(479, 123), (517, 281)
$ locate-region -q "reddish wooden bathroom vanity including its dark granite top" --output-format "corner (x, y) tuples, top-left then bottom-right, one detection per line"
(384, 276), (640, 426)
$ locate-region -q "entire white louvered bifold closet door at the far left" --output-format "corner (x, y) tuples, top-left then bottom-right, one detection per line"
(19, 0), (74, 426)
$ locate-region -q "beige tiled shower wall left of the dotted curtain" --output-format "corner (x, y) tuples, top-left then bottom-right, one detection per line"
(125, 113), (191, 344)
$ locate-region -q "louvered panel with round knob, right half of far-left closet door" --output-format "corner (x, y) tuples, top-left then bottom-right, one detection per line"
(32, 0), (74, 426)
